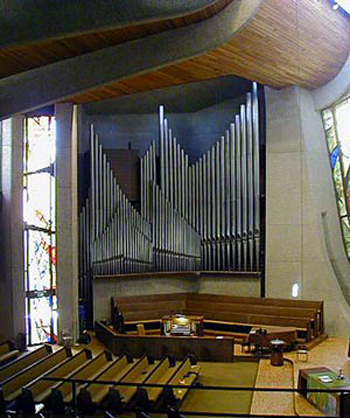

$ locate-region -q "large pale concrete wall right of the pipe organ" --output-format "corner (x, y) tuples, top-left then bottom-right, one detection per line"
(266, 87), (350, 336)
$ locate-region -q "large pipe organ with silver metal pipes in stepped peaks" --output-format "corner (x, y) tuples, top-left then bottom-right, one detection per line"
(79, 83), (260, 294)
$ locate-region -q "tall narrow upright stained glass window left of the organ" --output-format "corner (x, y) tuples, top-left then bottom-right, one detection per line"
(23, 116), (57, 345)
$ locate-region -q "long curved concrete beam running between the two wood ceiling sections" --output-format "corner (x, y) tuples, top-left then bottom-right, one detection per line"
(0, 0), (264, 119)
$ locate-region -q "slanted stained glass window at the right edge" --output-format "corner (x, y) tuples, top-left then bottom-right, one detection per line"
(322, 98), (350, 259)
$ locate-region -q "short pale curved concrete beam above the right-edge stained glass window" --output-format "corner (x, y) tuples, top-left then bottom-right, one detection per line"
(312, 51), (350, 110)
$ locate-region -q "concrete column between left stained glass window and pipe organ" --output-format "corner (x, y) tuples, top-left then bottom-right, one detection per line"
(56, 104), (78, 341)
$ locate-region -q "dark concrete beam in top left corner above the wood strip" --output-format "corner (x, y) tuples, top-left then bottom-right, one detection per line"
(0, 0), (217, 48)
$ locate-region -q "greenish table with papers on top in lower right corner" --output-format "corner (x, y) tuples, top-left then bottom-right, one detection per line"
(298, 367), (350, 417)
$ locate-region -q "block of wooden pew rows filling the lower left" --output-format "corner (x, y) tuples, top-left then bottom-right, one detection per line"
(0, 345), (199, 416)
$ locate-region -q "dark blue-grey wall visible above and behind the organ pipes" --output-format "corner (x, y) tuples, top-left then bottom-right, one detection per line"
(80, 96), (245, 162)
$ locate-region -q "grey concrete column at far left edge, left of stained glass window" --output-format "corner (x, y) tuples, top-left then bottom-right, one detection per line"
(0, 116), (25, 340)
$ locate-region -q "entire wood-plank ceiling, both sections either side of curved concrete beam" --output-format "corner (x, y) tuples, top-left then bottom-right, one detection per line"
(0, 0), (350, 103)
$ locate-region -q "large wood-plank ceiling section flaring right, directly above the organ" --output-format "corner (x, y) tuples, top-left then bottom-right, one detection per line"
(71, 0), (350, 103)
